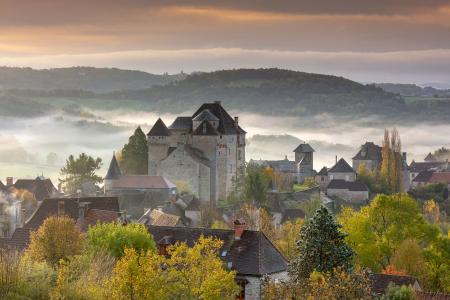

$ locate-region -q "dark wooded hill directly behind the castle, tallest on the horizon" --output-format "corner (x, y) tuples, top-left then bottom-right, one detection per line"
(104, 69), (404, 115)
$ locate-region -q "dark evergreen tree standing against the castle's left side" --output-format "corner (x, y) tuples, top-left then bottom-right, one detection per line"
(119, 127), (148, 175)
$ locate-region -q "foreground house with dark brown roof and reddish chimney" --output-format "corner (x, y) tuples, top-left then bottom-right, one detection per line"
(148, 222), (288, 300)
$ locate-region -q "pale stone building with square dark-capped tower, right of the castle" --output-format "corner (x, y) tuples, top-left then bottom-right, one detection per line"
(249, 143), (315, 183)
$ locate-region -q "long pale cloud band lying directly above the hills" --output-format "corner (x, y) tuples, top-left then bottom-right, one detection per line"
(0, 48), (450, 85)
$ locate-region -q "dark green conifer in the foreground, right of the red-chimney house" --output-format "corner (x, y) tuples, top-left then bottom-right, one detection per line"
(288, 206), (354, 282)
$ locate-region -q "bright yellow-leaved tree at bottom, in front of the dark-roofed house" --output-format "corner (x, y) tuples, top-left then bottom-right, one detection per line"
(110, 237), (239, 300)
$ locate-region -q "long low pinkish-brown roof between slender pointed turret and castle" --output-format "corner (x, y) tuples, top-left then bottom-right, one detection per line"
(112, 175), (176, 189)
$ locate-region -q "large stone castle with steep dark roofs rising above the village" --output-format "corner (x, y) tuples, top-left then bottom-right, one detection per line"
(147, 101), (246, 204)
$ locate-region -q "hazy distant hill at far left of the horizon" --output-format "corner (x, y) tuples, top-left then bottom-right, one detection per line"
(0, 67), (186, 92)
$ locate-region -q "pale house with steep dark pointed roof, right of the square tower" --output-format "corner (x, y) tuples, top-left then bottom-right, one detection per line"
(326, 158), (369, 204)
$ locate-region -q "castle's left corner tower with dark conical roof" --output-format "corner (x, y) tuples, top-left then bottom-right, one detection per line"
(147, 118), (170, 175)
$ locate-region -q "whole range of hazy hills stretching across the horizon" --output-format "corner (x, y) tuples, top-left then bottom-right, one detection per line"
(0, 67), (450, 121)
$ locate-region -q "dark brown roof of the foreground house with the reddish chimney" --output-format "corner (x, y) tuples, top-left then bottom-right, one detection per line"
(148, 226), (287, 277)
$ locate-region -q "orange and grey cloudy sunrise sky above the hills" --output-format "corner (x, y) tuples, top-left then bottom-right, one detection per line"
(0, 0), (450, 87)
